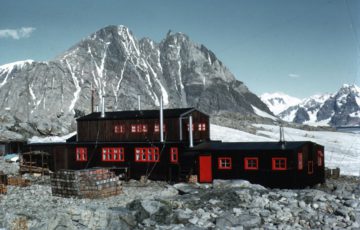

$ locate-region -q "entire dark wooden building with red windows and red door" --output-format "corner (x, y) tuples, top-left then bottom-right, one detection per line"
(28, 108), (325, 188)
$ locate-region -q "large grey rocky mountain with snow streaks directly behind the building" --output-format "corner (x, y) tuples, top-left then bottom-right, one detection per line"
(0, 26), (271, 138)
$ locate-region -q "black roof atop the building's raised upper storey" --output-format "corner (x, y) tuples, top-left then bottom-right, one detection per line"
(77, 108), (207, 121)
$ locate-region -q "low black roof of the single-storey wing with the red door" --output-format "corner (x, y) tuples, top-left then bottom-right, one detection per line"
(193, 141), (315, 151)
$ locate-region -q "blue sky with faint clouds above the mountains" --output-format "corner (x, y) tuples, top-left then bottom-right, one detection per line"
(0, 0), (360, 97)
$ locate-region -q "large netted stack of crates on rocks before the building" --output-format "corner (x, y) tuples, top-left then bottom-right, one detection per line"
(51, 168), (122, 199)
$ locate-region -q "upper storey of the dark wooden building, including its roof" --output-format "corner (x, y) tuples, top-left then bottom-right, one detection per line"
(77, 108), (210, 142)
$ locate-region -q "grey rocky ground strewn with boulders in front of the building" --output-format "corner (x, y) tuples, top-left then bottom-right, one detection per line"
(0, 157), (360, 229)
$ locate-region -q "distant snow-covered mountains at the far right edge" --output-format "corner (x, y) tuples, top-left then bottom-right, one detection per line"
(261, 84), (360, 127)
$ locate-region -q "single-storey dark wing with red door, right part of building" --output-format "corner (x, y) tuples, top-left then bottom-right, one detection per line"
(188, 142), (325, 188)
